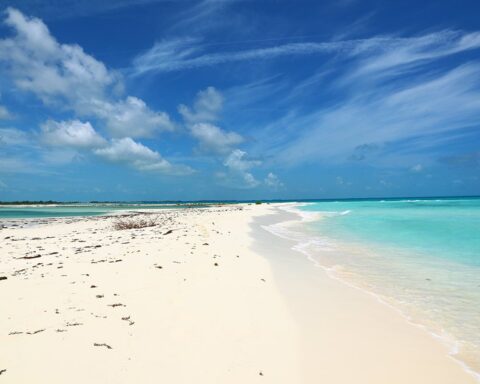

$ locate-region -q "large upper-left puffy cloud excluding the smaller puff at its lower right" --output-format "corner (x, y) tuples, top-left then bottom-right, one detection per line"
(0, 8), (118, 104)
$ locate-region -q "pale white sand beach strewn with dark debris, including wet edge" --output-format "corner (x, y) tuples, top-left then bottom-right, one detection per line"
(0, 205), (474, 384)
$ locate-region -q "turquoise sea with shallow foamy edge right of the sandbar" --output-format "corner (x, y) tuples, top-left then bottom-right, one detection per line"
(274, 198), (480, 378)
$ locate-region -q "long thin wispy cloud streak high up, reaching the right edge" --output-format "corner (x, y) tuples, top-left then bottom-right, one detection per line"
(133, 30), (480, 75)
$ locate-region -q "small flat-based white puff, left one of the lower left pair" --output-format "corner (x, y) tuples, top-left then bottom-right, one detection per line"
(40, 120), (107, 149)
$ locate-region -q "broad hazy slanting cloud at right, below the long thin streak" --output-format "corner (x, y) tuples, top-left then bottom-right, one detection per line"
(268, 63), (480, 165)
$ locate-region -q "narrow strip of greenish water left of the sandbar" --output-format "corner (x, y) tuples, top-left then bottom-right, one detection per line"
(0, 203), (180, 220)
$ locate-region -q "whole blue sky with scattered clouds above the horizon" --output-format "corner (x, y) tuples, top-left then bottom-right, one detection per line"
(0, 0), (480, 201)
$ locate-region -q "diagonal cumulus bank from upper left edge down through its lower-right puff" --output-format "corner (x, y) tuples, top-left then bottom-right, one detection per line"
(0, 8), (174, 137)
